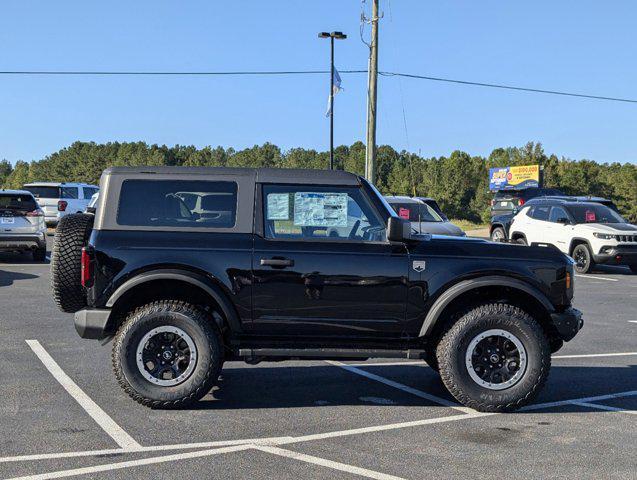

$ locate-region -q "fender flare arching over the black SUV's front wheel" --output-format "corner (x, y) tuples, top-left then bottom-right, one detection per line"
(419, 275), (555, 337)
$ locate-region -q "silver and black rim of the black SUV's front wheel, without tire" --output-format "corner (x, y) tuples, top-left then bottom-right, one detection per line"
(465, 328), (527, 390)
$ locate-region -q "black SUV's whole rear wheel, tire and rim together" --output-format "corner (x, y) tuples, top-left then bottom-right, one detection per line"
(112, 300), (223, 408)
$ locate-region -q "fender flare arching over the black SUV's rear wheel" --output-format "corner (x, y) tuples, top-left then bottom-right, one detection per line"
(106, 268), (241, 331)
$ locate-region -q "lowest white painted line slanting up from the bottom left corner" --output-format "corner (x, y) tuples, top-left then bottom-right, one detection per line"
(7, 445), (251, 480)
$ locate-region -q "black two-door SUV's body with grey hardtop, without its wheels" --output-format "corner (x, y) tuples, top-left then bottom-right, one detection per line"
(54, 167), (582, 408)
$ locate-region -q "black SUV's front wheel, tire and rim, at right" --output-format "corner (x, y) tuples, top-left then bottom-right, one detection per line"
(437, 303), (551, 412)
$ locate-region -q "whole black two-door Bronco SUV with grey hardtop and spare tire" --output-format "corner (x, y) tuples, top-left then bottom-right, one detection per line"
(52, 167), (582, 412)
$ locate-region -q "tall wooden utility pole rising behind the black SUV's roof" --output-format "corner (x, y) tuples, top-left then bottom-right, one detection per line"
(365, 0), (379, 183)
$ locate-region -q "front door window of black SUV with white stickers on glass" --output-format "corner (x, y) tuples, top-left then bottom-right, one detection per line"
(263, 185), (385, 241)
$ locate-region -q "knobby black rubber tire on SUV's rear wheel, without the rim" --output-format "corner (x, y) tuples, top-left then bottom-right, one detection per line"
(112, 300), (223, 409)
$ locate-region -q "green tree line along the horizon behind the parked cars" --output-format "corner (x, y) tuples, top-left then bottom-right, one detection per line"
(0, 142), (637, 222)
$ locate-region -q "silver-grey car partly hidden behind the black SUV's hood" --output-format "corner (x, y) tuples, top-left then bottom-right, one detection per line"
(385, 196), (466, 237)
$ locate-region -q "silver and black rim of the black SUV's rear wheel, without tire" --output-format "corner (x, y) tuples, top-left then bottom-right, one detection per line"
(135, 325), (197, 387)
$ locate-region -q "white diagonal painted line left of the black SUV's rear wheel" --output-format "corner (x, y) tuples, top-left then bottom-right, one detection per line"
(26, 340), (142, 450)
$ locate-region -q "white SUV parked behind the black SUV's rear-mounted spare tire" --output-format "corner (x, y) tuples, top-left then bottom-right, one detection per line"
(22, 182), (99, 226)
